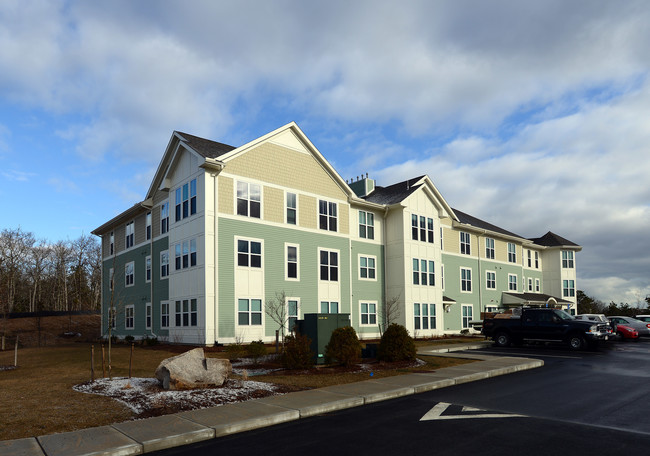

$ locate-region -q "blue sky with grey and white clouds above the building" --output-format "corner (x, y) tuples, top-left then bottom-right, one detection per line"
(0, 0), (650, 304)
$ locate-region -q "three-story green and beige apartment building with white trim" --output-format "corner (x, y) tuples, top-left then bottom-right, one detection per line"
(93, 123), (581, 345)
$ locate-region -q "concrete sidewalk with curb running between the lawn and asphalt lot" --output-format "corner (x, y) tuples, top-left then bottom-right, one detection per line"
(0, 341), (544, 456)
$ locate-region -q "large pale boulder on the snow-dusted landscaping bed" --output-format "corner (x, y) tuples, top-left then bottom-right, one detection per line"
(156, 348), (232, 389)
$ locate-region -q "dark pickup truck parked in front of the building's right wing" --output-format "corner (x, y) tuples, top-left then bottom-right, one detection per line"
(483, 308), (610, 350)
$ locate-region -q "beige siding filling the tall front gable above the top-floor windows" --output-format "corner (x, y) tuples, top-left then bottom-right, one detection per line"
(225, 142), (347, 200)
